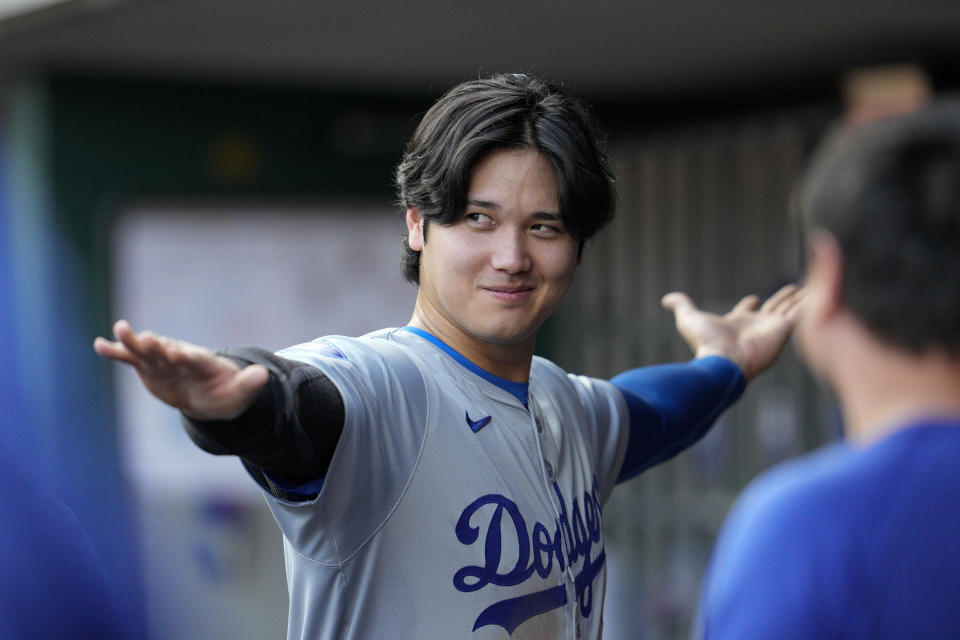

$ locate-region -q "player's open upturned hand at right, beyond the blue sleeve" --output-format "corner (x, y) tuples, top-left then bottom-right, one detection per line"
(660, 284), (806, 380)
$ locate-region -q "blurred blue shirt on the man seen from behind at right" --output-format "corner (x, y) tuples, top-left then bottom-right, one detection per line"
(699, 420), (960, 640)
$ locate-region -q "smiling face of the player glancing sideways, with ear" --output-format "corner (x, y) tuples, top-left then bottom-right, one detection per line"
(407, 149), (578, 353)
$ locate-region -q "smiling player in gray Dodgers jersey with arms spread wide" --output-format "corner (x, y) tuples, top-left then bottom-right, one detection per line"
(94, 74), (801, 640)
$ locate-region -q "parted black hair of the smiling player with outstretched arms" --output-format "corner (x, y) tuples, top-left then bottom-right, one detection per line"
(396, 73), (616, 284)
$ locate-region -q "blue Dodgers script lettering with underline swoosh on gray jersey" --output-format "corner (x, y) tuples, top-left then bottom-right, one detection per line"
(453, 477), (606, 634)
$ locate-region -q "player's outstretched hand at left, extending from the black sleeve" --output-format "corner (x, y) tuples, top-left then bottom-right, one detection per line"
(93, 320), (269, 421)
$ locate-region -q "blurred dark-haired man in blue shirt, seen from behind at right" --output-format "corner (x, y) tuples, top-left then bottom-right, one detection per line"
(700, 100), (960, 640)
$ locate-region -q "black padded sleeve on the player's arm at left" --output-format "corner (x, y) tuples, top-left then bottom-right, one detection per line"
(181, 347), (344, 482)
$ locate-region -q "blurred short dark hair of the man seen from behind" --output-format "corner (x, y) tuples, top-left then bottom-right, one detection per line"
(799, 100), (960, 356)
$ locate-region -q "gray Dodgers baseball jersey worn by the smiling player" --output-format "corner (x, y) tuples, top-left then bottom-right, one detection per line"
(267, 329), (628, 640)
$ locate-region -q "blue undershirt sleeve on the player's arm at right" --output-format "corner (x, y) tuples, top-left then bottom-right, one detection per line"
(610, 356), (746, 483)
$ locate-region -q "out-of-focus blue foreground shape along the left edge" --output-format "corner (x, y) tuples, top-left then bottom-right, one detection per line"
(0, 127), (135, 640)
